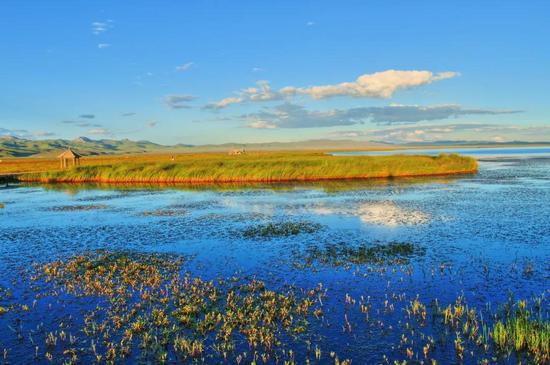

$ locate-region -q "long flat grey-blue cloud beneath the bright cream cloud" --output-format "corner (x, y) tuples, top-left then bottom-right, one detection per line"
(241, 103), (519, 129)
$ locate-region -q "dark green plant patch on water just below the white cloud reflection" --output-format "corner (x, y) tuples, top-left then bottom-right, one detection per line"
(296, 242), (425, 267)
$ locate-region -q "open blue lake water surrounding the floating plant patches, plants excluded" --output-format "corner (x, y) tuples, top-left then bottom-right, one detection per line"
(0, 148), (550, 364)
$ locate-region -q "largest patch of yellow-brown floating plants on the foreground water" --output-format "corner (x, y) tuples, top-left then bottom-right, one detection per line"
(10, 251), (334, 364)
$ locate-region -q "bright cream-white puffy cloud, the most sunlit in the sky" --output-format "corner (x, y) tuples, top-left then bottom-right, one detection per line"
(205, 70), (458, 109)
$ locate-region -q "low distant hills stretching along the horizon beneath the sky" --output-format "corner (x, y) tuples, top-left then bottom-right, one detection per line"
(0, 136), (550, 158)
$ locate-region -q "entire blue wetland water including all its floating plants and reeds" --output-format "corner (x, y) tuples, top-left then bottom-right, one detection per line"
(0, 150), (550, 364)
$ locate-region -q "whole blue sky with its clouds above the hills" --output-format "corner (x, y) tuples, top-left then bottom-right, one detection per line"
(0, 0), (550, 144)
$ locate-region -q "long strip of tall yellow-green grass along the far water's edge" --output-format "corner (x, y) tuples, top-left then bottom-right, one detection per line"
(20, 153), (477, 183)
